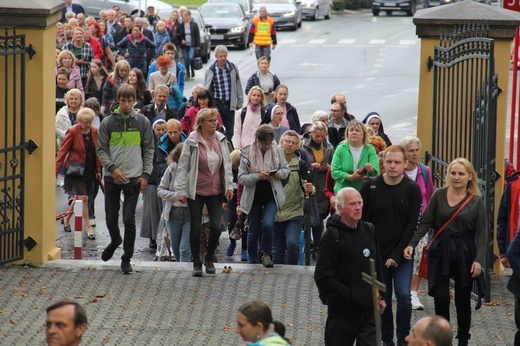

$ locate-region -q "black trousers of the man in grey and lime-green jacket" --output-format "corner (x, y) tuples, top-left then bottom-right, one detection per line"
(105, 179), (141, 262)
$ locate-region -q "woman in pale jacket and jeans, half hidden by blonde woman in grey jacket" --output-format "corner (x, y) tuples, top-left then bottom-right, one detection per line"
(157, 143), (191, 262)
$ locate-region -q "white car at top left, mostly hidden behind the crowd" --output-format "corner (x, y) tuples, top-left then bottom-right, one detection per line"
(74, 0), (173, 18)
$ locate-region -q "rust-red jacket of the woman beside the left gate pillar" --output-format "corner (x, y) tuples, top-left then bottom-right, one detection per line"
(56, 124), (101, 175)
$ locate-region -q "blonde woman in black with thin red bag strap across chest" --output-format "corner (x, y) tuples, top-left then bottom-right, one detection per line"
(404, 158), (490, 346)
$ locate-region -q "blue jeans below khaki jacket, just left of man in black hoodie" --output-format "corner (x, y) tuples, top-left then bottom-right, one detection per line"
(273, 216), (303, 265)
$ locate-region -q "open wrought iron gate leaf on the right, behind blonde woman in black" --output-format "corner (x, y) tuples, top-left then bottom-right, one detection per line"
(426, 23), (502, 301)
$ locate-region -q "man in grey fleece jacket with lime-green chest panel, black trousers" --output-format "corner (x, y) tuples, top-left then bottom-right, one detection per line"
(97, 85), (154, 274)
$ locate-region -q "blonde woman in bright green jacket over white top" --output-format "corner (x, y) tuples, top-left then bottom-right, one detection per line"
(331, 120), (379, 193)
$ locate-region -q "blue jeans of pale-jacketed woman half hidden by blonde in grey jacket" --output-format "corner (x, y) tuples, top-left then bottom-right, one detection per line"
(166, 206), (191, 262)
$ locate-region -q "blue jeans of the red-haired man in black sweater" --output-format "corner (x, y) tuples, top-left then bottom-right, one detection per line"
(381, 258), (413, 343)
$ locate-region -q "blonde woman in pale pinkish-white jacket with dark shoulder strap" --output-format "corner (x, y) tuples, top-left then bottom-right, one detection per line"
(230, 86), (265, 149)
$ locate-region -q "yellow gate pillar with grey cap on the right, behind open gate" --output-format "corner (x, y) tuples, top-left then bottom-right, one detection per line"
(413, 0), (520, 273)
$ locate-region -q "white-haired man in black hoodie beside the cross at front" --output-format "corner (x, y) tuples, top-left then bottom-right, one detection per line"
(314, 187), (386, 346)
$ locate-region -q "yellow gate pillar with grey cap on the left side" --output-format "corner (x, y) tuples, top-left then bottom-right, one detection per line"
(0, 0), (65, 264)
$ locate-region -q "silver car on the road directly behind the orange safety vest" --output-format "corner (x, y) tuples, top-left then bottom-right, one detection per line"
(254, 0), (302, 30)
